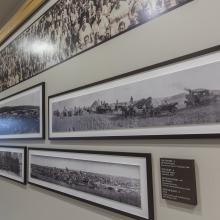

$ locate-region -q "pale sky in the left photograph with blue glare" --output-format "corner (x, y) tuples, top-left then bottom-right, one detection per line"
(0, 91), (40, 108)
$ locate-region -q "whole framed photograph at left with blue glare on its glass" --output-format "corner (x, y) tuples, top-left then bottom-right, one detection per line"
(0, 83), (45, 139)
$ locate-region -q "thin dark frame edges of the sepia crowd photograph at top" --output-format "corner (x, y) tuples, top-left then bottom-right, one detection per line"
(0, 0), (194, 92)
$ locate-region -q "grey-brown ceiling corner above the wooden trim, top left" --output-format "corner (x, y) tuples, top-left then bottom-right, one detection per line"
(0, 0), (26, 29)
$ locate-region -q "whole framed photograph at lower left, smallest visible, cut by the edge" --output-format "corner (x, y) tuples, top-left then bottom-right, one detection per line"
(0, 146), (27, 184)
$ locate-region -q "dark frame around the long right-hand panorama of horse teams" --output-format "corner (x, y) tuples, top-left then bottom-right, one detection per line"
(48, 45), (220, 140)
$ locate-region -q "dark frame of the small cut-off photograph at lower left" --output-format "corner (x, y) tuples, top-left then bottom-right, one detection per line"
(0, 145), (27, 185)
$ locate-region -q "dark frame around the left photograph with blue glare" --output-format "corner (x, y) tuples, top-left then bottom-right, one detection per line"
(0, 82), (45, 140)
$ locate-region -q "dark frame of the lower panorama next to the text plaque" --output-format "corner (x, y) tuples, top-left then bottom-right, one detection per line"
(28, 147), (154, 220)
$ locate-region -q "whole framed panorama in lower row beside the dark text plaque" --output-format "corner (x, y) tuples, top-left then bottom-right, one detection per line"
(28, 148), (154, 220)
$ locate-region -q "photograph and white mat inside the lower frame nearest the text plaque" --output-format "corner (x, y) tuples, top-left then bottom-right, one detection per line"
(29, 149), (153, 220)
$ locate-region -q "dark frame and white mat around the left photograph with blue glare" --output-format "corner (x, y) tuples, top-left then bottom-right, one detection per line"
(0, 82), (45, 140)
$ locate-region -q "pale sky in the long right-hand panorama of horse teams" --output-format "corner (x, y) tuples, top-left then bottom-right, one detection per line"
(53, 62), (220, 110)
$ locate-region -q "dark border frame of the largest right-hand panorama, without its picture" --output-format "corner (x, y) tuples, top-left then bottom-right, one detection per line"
(48, 45), (220, 140)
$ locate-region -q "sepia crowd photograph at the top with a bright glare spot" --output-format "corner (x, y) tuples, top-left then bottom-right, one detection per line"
(0, 0), (192, 91)
